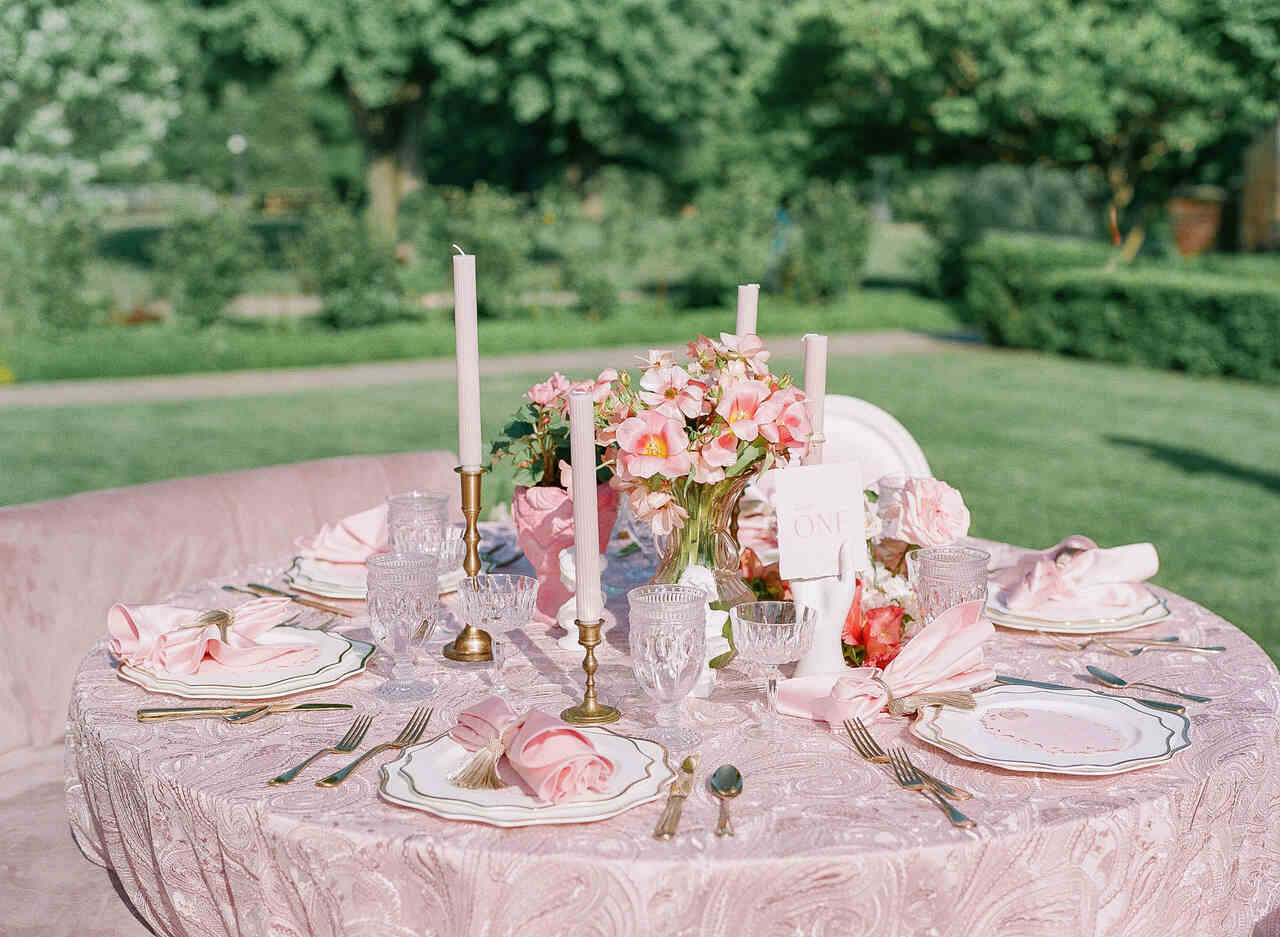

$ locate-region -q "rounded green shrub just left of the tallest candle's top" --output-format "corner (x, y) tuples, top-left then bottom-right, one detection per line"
(285, 205), (412, 329)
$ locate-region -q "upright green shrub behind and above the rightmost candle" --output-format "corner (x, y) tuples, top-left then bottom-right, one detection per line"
(783, 180), (870, 302)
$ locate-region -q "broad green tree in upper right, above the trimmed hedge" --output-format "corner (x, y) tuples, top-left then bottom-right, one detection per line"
(758, 0), (1280, 207)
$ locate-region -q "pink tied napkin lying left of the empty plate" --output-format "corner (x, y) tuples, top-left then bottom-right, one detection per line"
(778, 602), (996, 727)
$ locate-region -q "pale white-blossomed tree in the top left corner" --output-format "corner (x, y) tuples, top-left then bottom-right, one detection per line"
(0, 0), (178, 191)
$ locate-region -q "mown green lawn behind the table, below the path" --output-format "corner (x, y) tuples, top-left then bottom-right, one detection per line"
(0, 348), (1280, 658)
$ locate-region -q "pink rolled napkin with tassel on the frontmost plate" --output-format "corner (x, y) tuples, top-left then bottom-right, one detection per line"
(451, 696), (613, 804)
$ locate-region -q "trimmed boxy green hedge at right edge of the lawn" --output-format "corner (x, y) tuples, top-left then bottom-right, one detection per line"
(965, 237), (1280, 383)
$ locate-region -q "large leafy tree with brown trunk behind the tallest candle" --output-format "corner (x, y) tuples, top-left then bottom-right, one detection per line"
(193, 0), (768, 236)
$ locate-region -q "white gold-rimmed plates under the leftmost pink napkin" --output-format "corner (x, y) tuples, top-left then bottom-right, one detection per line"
(116, 626), (374, 700)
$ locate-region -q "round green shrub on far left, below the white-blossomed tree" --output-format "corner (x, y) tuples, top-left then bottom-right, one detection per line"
(152, 206), (262, 328)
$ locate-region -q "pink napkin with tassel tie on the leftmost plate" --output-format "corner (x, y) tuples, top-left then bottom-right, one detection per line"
(106, 598), (315, 675)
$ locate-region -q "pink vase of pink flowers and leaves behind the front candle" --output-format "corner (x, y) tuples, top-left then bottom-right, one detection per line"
(492, 369), (618, 620)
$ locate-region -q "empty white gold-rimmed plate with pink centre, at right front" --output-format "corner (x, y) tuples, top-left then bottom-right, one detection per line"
(911, 686), (1190, 774)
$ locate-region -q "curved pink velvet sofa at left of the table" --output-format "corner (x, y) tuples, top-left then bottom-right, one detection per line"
(0, 452), (461, 937)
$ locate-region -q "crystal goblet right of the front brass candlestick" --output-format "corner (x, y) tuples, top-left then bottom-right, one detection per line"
(627, 585), (707, 749)
